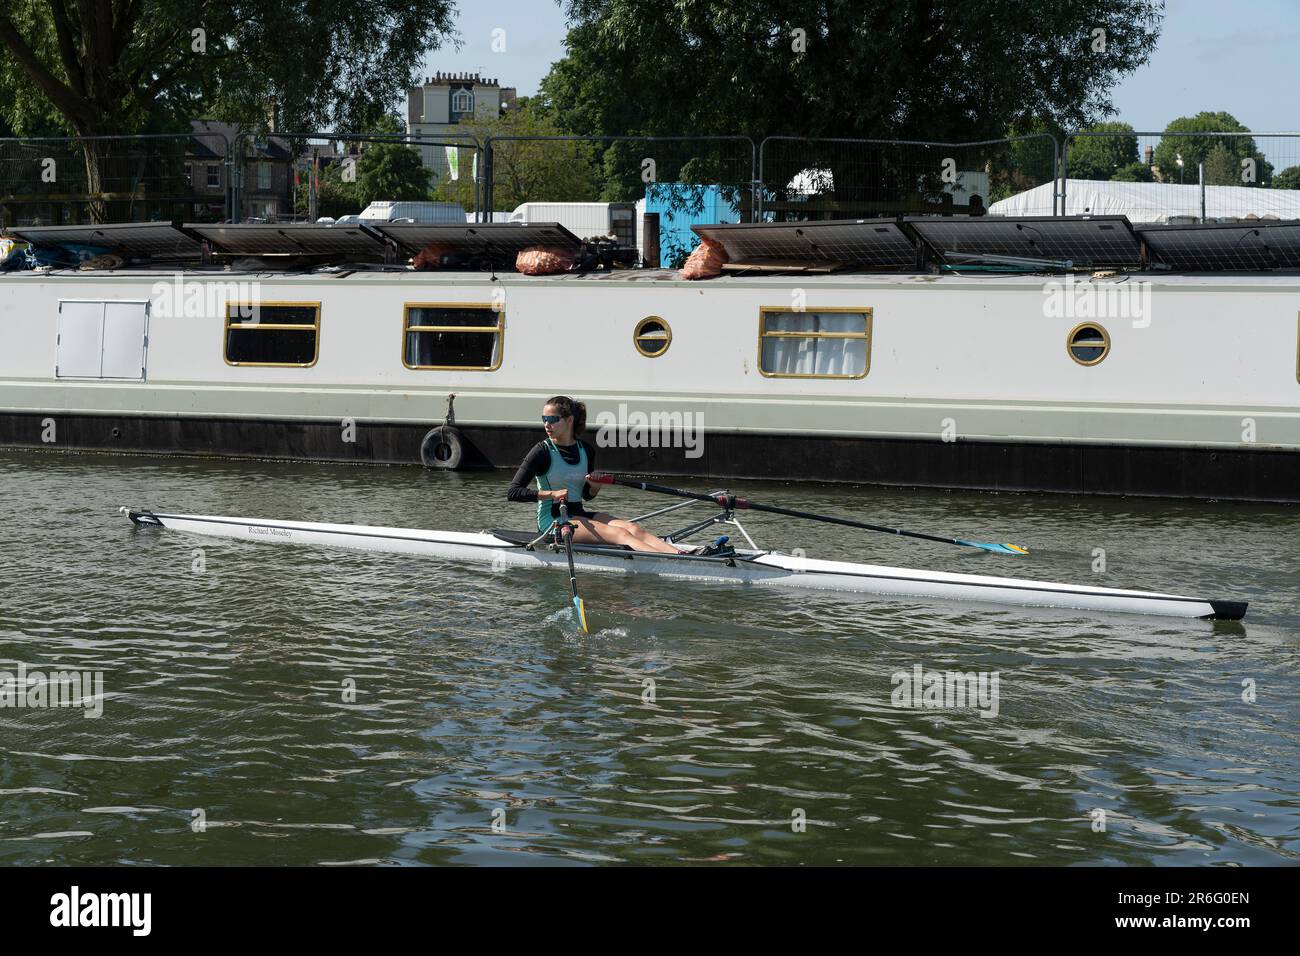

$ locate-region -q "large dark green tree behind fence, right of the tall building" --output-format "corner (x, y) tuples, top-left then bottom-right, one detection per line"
(541, 0), (1162, 217)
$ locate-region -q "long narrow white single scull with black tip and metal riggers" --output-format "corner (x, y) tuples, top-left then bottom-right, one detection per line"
(121, 488), (1247, 620)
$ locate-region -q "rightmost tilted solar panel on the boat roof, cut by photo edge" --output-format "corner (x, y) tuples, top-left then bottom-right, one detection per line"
(1136, 222), (1300, 272)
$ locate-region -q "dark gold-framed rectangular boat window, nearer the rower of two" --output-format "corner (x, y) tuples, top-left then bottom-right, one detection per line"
(402, 303), (506, 372)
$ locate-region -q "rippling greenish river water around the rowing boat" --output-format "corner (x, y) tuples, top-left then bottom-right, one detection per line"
(0, 451), (1300, 865)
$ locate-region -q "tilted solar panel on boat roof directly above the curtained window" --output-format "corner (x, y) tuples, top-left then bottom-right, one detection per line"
(692, 219), (917, 268)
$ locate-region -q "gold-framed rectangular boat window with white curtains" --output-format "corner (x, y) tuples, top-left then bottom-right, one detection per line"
(758, 308), (871, 378)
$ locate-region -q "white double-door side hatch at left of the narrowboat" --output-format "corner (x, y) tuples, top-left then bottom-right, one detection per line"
(55, 302), (150, 381)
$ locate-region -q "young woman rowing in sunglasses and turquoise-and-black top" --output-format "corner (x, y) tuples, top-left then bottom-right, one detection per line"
(506, 395), (692, 554)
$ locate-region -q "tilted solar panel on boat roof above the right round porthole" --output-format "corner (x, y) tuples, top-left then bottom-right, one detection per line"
(905, 216), (1141, 268)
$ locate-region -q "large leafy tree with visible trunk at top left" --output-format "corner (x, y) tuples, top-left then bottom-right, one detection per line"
(0, 0), (451, 217)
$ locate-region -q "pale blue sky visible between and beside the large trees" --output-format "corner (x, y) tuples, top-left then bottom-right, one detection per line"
(424, 0), (1300, 151)
